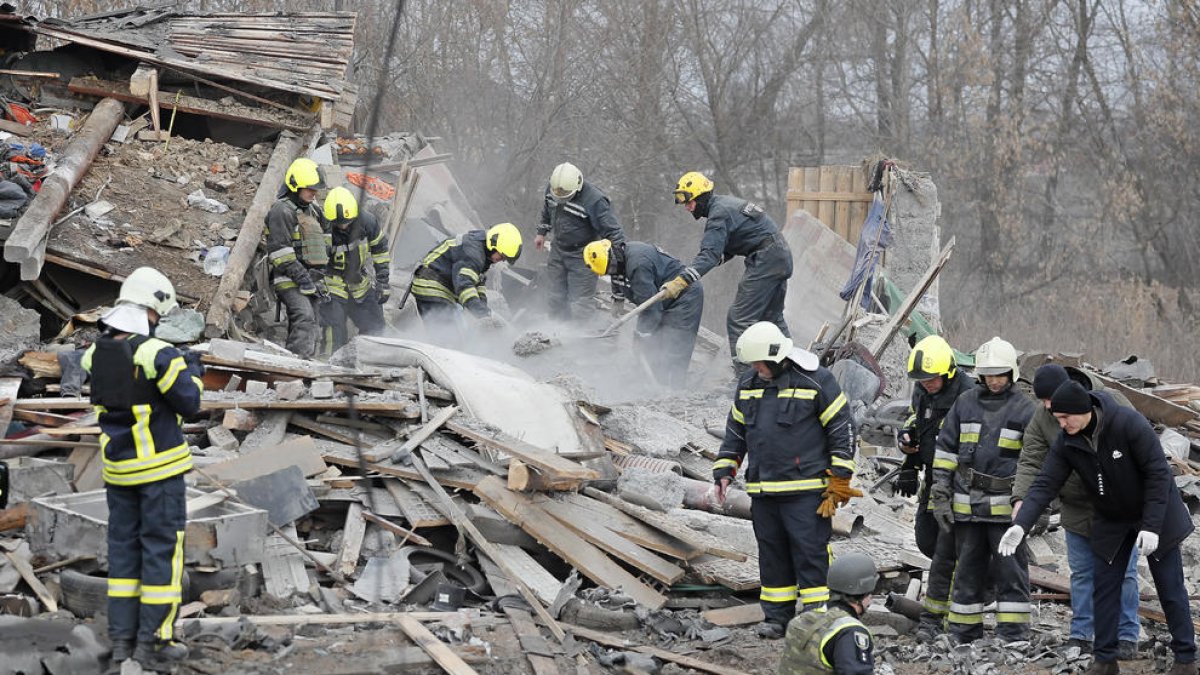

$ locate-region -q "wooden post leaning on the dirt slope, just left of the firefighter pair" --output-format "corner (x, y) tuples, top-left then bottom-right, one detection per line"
(204, 126), (314, 338)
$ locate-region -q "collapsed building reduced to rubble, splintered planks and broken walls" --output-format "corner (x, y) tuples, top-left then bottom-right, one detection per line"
(0, 5), (1200, 674)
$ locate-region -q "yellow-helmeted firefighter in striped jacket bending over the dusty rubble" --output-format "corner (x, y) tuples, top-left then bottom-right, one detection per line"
(412, 222), (522, 344)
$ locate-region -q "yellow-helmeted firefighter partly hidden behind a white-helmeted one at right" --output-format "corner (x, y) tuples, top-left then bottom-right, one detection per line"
(895, 335), (976, 640)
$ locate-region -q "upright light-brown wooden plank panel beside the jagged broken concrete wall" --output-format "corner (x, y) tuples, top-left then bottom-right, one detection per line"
(787, 166), (874, 244)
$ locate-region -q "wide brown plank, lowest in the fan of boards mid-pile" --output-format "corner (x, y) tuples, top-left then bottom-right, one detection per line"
(474, 476), (666, 609)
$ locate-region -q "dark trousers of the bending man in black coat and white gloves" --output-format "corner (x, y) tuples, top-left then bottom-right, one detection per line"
(1092, 532), (1196, 663)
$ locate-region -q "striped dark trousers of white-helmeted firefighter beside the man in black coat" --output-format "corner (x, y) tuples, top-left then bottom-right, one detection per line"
(948, 522), (1032, 641)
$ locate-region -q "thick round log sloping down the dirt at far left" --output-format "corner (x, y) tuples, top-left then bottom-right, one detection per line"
(4, 98), (125, 281)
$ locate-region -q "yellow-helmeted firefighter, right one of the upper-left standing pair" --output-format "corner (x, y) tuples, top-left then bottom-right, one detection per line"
(320, 187), (391, 351)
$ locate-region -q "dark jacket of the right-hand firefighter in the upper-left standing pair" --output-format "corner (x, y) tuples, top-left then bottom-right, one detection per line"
(325, 207), (391, 300)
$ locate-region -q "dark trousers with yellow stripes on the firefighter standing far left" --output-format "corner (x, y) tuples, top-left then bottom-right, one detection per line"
(107, 476), (187, 643)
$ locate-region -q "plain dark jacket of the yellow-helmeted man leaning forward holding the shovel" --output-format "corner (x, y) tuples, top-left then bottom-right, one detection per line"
(691, 195), (779, 276)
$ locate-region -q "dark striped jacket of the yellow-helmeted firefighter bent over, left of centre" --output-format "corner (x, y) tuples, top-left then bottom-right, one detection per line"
(413, 229), (492, 317)
